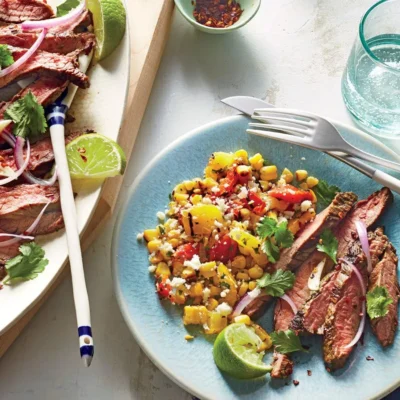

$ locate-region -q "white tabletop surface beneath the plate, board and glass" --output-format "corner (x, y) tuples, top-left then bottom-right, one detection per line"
(0, 0), (400, 400)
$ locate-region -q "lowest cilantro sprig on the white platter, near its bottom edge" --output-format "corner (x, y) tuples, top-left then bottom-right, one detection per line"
(3, 242), (49, 284)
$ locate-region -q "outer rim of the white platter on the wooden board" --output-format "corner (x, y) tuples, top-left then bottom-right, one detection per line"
(0, 6), (132, 336)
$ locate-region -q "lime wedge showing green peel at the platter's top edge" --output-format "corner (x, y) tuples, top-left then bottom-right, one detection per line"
(87, 0), (126, 61)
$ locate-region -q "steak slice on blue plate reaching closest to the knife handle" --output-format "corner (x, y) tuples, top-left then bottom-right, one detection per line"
(336, 188), (393, 258)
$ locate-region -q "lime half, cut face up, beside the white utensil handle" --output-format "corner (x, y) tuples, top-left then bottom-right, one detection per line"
(66, 133), (126, 179)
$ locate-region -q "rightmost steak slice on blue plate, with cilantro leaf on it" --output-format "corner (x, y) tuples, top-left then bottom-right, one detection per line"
(368, 243), (399, 347)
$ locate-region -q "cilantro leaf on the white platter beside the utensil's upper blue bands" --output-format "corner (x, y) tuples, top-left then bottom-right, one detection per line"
(4, 91), (47, 138)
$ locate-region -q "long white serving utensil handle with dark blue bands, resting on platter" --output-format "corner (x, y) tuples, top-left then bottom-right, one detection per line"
(46, 52), (94, 367)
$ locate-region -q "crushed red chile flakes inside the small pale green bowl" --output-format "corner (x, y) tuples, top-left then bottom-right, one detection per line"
(192, 0), (243, 28)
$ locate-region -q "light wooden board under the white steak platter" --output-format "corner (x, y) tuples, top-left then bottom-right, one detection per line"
(0, 0), (174, 357)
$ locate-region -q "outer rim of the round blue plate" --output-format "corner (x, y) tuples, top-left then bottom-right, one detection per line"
(111, 114), (400, 400)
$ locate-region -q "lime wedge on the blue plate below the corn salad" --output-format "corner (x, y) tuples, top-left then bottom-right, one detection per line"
(213, 323), (272, 379)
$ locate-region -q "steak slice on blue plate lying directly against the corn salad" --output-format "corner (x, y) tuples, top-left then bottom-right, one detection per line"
(274, 192), (357, 270)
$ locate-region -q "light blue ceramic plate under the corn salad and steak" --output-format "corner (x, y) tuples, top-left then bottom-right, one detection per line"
(113, 116), (400, 400)
